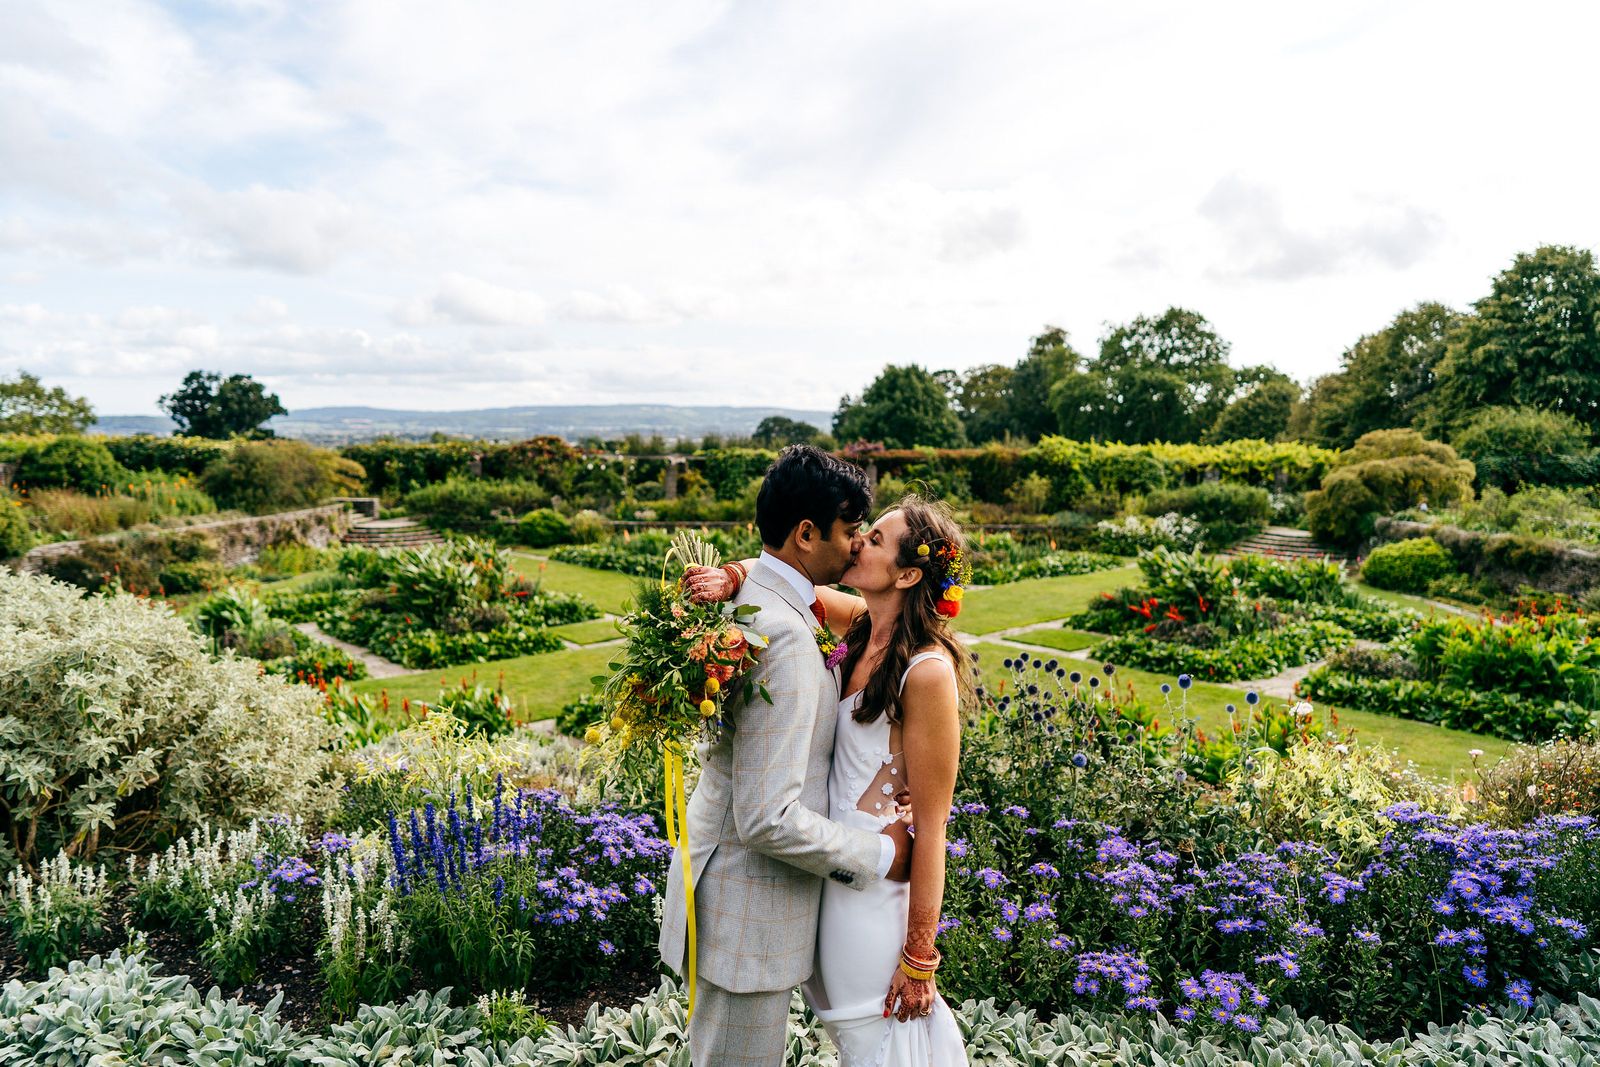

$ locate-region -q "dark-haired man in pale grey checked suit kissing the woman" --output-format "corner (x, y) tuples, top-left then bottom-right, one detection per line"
(661, 445), (910, 1067)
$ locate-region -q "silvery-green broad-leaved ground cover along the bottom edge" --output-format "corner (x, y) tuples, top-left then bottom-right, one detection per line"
(0, 952), (1600, 1067)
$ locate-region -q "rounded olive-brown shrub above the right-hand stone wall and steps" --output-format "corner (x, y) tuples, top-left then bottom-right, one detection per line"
(1306, 430), (1472, 544)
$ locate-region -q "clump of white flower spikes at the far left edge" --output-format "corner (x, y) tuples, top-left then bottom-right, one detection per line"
(0, 853), (107, 971)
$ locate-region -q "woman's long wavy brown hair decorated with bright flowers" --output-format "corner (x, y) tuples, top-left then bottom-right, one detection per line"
(842, 494), (973, 723)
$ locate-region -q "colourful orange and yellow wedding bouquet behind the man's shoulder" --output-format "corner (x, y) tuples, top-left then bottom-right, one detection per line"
(584, 533), (771, 771)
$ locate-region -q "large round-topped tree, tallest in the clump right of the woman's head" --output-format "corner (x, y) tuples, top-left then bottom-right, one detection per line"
(1040, 307), (1235, 443)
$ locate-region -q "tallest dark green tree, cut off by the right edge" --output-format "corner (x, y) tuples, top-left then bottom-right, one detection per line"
(1427, 245), (1600, 432)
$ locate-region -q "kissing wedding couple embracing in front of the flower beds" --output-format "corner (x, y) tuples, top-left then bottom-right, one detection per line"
(661, 445), (973, 1067)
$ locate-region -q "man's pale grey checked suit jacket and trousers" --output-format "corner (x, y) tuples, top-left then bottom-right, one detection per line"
(661, 557), (893, 1067)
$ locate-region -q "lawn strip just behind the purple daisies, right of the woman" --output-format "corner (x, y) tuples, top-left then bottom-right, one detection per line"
(973, 643), (1512, 779)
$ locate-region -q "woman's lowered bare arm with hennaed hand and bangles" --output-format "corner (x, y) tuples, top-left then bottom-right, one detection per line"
(883, 661), (962, 1021)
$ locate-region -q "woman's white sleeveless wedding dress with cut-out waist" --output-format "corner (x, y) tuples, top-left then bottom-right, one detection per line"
(803, 653), (966, 1067)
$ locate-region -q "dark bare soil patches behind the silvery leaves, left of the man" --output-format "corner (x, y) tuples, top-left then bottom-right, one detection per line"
(0, 889), (661, 1032)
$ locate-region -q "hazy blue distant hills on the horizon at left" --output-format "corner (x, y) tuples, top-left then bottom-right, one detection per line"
(90, 403), (834, 445)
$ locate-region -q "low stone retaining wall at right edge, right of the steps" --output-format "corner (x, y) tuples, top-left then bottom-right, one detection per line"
(1373, 518), (1600, 597)
